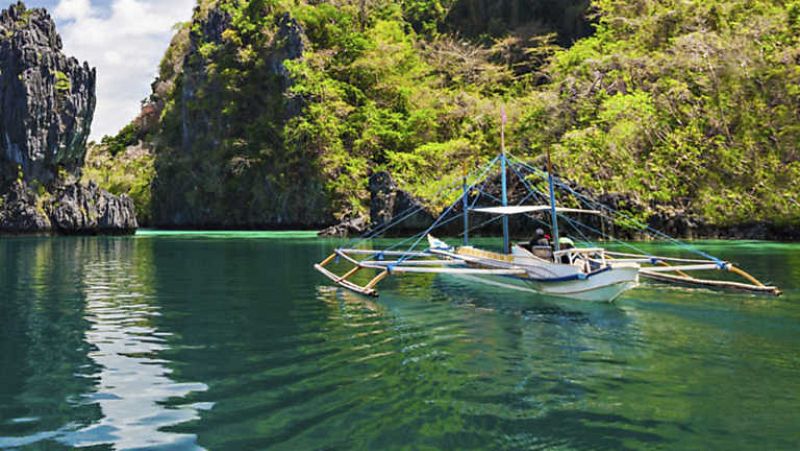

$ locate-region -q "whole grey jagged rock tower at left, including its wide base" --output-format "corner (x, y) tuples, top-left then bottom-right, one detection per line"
(0, 2), (136, 234)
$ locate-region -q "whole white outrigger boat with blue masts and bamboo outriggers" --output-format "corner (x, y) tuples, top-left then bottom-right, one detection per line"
(314, 117), (780, 302)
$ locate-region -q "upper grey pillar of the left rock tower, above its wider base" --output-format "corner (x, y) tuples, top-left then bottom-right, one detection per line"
(0, 2), (96, 186)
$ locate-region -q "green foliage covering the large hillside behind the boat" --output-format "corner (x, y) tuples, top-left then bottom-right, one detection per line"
(87, 0), (800, 231)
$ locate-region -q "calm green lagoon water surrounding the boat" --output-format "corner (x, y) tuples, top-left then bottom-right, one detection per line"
(0, 232), (800, 449)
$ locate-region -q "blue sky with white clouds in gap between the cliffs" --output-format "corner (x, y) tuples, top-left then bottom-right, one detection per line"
(0, 0), (195, 140)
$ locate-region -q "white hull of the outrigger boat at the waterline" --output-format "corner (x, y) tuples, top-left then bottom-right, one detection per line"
(458, 266), (639, 302)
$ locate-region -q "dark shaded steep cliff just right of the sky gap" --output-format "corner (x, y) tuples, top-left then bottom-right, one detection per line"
(152, 4), (318, 229)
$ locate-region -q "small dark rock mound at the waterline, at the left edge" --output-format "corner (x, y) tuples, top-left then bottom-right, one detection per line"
(0, 181), (50, 234)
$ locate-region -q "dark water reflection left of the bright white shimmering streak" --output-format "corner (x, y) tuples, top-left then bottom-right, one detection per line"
(0, 238), (101, 447)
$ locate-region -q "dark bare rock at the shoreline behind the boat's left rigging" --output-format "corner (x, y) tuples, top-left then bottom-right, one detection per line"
(369, 172), (435, 233)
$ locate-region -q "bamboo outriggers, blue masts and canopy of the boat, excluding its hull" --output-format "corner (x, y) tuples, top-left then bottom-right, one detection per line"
(314, 112), (781, 302)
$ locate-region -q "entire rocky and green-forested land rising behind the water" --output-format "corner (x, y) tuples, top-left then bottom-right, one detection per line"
(0, 0), (800, 239)
